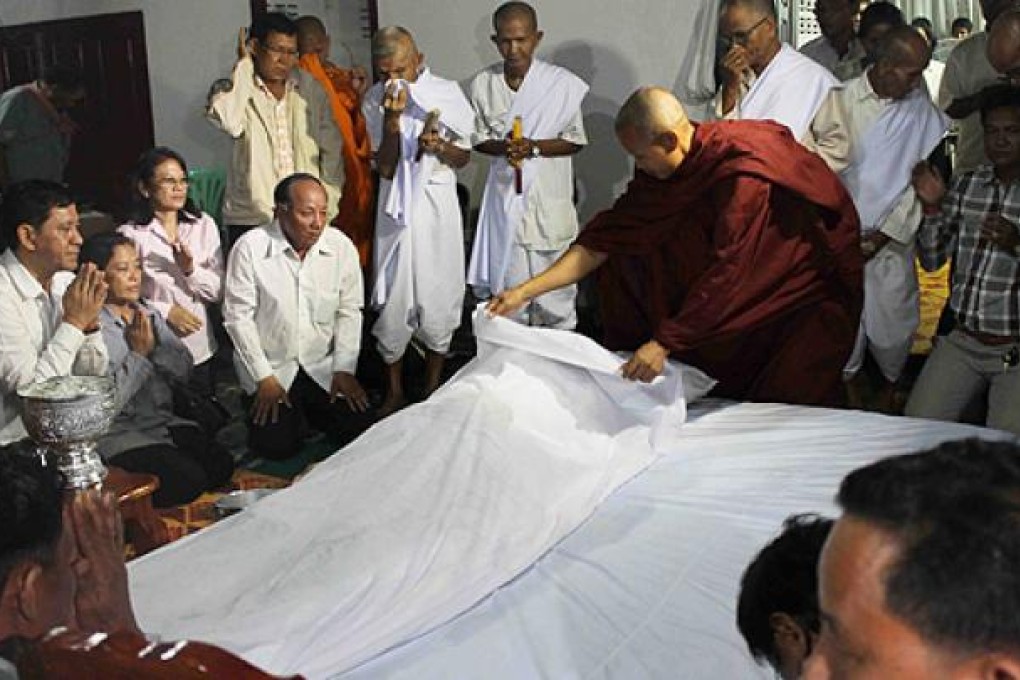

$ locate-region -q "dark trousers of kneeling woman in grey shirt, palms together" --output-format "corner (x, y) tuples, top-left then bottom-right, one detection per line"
(109, 425), (234, 508)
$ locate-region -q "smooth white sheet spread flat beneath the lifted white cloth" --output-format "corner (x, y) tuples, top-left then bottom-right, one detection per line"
(339, 401), (1010, 680)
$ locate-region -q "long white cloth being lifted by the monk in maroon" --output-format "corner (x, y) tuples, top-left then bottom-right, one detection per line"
(130, 314), (711, 678)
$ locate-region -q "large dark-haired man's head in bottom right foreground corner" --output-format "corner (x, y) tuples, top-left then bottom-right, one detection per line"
(804, 439), (1020, 680)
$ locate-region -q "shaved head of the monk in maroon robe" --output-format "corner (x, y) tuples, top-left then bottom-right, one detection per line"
(616, 88), (695, 179)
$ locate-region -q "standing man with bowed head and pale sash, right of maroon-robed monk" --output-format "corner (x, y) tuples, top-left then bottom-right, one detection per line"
(805, 27), (949, 409)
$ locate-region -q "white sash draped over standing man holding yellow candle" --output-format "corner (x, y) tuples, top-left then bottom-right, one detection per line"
(467, 59), (589, 295)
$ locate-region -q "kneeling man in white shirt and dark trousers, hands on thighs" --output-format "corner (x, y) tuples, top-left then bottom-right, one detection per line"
(223, 173), (368, 459)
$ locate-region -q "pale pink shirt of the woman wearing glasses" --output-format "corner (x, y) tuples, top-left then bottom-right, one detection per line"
(117, 213), (223, 364)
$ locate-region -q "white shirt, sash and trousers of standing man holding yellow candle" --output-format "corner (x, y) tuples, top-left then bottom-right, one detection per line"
(467, 59), (589, 328)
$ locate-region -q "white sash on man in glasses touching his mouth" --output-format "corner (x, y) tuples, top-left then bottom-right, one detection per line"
(715, 43), (839, 140)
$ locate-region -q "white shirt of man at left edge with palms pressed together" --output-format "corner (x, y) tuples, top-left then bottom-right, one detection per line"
(0, 249), (106, 444)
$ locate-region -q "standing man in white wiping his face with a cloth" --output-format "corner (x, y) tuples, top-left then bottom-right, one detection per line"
(362, 27), (474, 416)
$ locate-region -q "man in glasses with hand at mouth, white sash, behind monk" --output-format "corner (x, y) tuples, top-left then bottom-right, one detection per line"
(715, 0), (839, 139)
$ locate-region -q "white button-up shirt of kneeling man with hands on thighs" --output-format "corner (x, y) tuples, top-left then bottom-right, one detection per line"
(223, 220), (364, 394)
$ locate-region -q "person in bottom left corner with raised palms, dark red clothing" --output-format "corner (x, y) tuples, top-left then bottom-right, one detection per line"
(0, 450), (297, 680)
